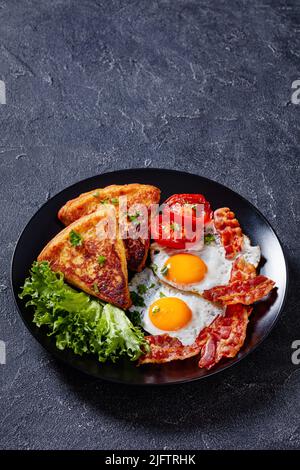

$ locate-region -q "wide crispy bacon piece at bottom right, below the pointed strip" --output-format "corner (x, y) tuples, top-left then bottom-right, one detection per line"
(198, 304), (252, 369)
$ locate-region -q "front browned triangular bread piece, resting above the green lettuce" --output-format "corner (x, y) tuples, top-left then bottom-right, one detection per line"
(38, 209), (131, 309)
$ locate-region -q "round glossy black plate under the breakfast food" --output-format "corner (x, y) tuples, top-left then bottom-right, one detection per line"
(11, 169), (288, 385)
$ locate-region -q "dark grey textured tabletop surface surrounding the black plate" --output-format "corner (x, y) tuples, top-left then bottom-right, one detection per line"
(0, 0), (300, 449)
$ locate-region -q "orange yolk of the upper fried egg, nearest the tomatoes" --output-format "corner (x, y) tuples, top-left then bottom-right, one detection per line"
(165, 253), (207, 284)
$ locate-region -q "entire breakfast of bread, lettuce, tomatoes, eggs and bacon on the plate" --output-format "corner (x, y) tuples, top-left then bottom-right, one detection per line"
(21, 184), (275, 369)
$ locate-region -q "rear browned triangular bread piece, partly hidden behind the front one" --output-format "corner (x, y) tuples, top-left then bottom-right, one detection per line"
(58, 183), (160, 271)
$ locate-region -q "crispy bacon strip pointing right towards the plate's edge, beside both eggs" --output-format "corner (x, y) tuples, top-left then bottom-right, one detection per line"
(203, 275), (275, 305)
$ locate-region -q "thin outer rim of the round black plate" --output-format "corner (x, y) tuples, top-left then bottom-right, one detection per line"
(10, 167), (290, 387)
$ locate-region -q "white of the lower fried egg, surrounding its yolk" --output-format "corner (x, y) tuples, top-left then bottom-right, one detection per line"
(129, 268), (225, 345)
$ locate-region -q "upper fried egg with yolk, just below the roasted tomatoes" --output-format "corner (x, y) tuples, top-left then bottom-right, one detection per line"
(151, 235), (260, 295)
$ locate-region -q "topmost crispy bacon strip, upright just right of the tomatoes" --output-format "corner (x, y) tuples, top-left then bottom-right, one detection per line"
(214, 207), (243, 259)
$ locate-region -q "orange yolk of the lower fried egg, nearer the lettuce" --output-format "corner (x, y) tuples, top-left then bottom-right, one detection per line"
(149, 297), (192, 331)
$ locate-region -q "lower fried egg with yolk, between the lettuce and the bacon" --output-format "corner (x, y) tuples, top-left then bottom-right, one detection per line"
(129, 268), (225, 345)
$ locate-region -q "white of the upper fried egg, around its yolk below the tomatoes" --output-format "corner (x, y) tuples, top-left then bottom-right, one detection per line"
(151, 235), (260, 295)
